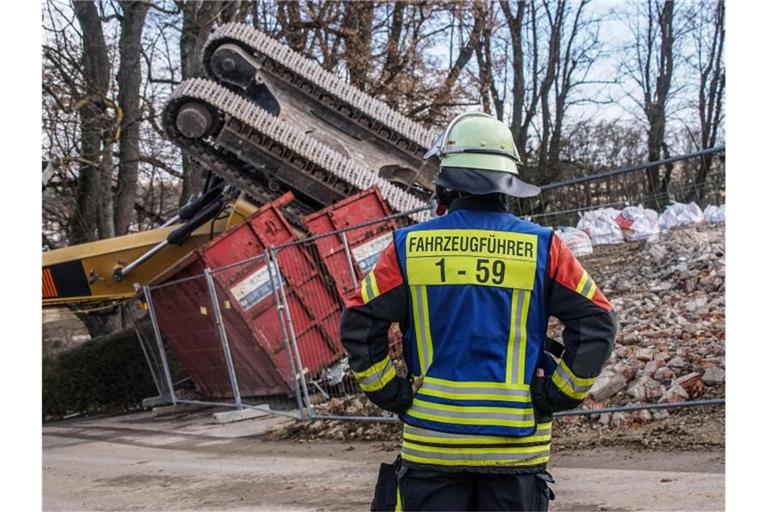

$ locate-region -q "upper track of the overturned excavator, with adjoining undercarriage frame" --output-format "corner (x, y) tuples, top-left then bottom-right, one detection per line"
(203, 23), (438, 199)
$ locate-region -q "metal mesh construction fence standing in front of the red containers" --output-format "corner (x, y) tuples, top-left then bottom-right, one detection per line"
(139, 147), (724, 421)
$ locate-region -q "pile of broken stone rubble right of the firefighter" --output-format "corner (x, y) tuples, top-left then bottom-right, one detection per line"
(576, 224), (725, 426)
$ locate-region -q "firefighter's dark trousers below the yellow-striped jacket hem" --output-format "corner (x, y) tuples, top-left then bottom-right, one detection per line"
(372, 464), (554, 512)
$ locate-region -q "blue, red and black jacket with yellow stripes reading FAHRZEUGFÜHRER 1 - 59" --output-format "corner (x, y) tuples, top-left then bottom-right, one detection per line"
(341, 198), (615, 470)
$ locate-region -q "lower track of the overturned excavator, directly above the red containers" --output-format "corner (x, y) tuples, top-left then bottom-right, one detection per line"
(163, 78), (428, 221)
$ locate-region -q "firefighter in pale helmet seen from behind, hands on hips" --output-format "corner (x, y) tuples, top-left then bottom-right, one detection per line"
(341, 113), (616, 510)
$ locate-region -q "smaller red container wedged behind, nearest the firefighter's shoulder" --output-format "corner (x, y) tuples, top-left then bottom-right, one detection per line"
(303, 187), (397, 297)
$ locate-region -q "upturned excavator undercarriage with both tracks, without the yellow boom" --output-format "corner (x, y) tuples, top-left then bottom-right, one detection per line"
(163, 23), (438, 220)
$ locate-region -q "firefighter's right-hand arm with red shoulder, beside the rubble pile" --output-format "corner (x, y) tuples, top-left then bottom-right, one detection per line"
(537, 235), (616, 412)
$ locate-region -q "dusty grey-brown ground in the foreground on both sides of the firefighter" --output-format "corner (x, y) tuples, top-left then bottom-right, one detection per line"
(43, 410), (725, 511)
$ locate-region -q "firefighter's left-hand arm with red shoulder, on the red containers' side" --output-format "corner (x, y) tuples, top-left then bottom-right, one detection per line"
(341, 244), (413, 414)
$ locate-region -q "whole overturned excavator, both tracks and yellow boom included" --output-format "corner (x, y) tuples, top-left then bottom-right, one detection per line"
(43, 23), (438, 306)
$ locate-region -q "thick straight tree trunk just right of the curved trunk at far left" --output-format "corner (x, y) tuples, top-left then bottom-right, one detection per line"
(114, 1), (149, 235)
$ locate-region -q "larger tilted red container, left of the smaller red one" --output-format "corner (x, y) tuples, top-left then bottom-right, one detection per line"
(152, 194), (344, 398)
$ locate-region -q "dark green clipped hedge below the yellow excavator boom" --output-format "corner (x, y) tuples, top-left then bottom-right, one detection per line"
(43, 329), (157, 418)
